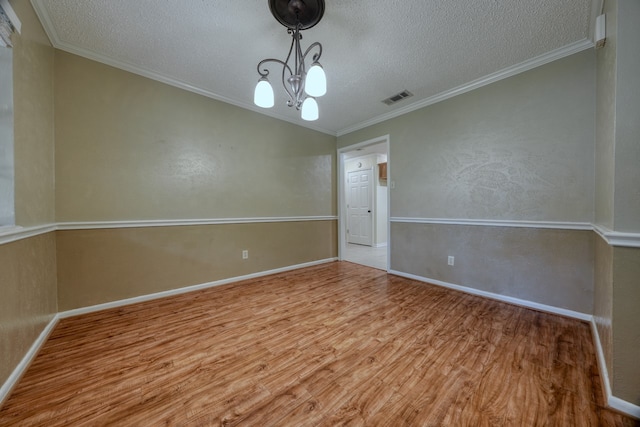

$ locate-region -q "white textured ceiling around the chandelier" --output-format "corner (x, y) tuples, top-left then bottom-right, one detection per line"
(31, 0), (595, 135)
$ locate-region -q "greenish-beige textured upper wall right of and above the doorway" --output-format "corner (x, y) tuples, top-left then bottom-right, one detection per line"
(338, 51), (595, 222)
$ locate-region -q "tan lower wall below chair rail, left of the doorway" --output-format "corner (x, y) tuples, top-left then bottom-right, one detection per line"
(57, 221), (337, 311)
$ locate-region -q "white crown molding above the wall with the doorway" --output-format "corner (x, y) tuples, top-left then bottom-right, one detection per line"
(337, 39), (593, 136)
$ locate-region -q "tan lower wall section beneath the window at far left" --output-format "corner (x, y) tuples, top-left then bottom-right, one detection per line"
(0, 233), (57, 384)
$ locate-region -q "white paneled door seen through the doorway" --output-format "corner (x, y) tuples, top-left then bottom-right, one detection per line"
(347, 169), (373, 246)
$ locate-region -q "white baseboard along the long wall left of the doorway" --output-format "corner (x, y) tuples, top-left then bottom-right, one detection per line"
(58, 258), (338, 319)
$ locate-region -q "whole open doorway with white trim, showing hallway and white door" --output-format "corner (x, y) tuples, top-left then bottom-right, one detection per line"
(338, 135), (390, 271)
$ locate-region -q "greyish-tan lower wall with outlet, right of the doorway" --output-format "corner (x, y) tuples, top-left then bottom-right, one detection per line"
(391, 223), (594, 314)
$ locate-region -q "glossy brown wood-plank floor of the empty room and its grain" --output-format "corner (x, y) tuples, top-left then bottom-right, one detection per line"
(0, 262), (636, 426)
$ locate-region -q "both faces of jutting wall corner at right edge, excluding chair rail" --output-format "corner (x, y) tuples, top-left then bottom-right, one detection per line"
(594, 0), (640, 405)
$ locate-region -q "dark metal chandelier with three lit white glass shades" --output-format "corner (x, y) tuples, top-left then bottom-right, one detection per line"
(253, 0), (327, 120)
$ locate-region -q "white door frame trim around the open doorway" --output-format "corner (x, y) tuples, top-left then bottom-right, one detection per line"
(337, 134), (392, 271)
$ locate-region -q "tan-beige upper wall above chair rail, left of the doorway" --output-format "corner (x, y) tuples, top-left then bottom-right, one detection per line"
(55, 51), (336, 221)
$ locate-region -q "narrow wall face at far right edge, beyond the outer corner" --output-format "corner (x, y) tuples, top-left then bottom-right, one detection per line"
(612, 0), (640, 406)
